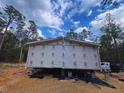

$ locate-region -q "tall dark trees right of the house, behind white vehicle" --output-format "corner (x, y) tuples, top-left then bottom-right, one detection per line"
(99, 13), (124, 68)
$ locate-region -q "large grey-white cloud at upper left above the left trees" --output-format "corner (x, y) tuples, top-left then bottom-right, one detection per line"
(2, 0), (63, 28)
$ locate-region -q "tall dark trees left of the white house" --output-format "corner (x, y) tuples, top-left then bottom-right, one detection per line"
(0, 5), (43, 61)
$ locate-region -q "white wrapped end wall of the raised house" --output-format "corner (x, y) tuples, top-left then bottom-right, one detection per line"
(26, 41), (100, 70)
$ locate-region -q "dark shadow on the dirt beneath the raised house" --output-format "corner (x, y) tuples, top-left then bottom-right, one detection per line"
(28, 71), (116, 89)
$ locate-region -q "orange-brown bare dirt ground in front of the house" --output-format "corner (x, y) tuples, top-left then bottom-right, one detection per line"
(0, 62), (124, 93)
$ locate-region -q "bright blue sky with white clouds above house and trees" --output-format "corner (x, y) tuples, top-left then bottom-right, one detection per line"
(0, 0), (124, 38)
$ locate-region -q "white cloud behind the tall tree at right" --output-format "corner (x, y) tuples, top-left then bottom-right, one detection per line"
(90, 4), (124, 31)
